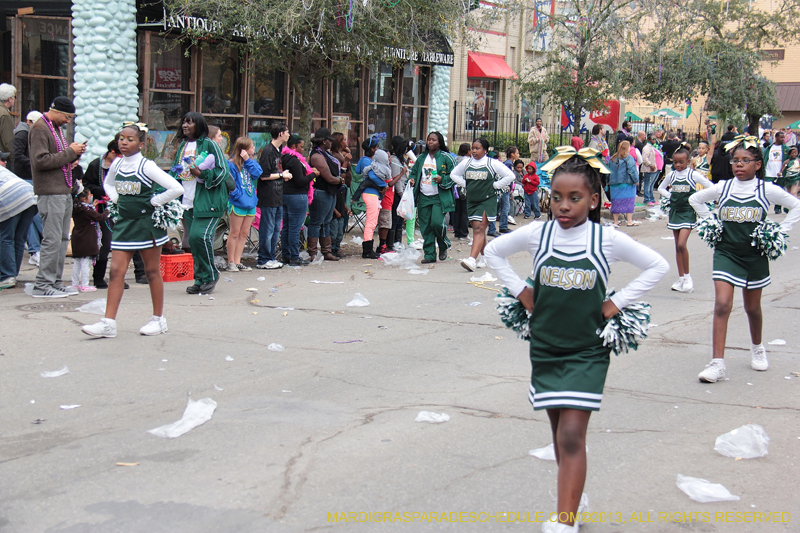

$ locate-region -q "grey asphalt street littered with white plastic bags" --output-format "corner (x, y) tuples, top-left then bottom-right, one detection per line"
(0, 210), (800, 533)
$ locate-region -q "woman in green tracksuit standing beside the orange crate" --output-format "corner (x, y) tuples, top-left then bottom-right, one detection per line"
(170, 111), (230, 294)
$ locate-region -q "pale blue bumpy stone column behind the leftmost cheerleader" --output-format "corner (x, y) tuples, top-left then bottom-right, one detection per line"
(72, 0), (139, 164)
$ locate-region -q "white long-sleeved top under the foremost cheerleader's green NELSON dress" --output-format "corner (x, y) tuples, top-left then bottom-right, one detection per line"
(485, 221), (669, 309)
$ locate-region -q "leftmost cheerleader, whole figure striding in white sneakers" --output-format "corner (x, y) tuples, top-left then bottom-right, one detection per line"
(82, 124), (184, 337)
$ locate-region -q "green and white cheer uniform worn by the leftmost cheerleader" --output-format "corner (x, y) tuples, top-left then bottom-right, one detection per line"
(103, 152), (183, 250)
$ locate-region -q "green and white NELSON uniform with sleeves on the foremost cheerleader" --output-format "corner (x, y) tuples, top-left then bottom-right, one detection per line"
(486, 221), (669, 411)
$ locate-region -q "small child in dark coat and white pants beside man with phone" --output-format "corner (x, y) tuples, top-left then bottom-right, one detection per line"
(69, 185), (106, 292)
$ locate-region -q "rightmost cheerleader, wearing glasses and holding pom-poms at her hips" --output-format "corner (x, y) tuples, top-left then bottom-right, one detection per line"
(689, 135), (800, 383)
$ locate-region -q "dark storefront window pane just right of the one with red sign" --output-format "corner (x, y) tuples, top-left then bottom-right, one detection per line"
(201, 46), (242, 115)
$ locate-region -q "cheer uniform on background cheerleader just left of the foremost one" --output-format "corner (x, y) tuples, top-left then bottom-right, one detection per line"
(450, 156), (515, 222)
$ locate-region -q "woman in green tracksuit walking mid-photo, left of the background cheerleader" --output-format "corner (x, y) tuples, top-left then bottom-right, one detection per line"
(409, 131), (456, 263)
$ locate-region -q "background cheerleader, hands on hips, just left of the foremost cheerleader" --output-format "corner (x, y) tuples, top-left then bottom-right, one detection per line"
(450, 138), (516, 272)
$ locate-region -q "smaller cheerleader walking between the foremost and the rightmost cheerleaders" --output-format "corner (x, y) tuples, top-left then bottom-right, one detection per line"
(658, 146), (714, 292)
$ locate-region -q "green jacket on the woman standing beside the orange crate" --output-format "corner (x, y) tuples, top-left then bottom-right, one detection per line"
(169, 137), (230, 218)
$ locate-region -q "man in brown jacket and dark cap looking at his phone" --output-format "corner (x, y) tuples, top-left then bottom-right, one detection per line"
(28, 96), (86, 298)
